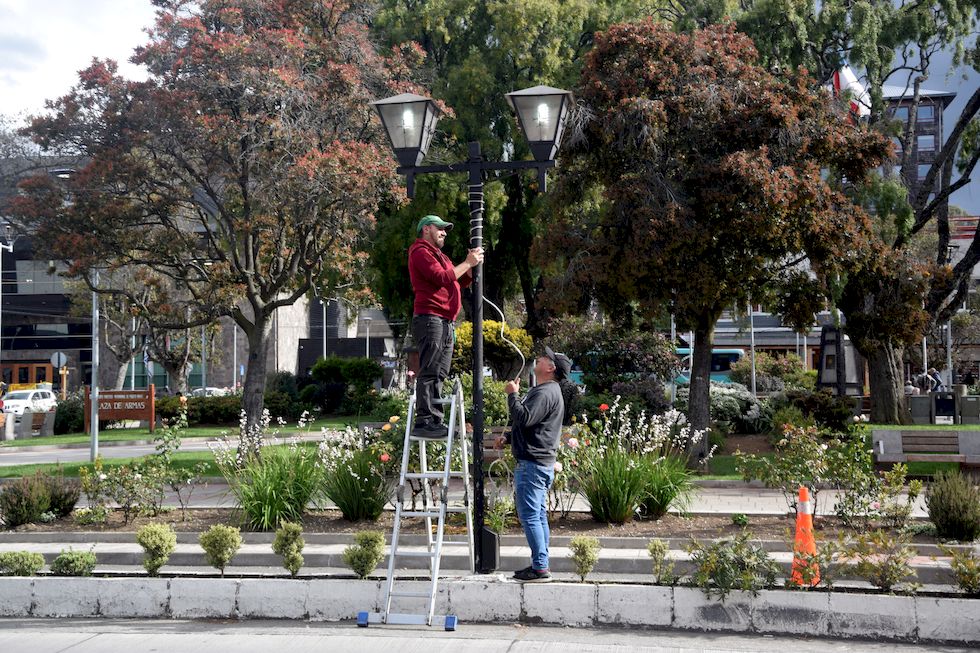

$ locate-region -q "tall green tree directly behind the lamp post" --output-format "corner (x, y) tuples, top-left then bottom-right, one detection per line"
(372, 0), (663, 337)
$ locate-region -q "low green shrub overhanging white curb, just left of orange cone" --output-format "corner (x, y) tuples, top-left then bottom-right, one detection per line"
(687, 533), (779, 601)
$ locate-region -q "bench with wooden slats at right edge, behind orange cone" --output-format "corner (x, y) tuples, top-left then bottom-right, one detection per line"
(871, 429), (980, 471)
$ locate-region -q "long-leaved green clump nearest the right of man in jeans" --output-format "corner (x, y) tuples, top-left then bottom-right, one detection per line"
(576, 447), (652, 524)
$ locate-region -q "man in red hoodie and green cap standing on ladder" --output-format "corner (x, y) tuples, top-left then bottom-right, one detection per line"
(408, 215), (483, 438)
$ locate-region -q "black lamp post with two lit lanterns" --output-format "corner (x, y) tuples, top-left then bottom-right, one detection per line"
(371, 86), (572, 573)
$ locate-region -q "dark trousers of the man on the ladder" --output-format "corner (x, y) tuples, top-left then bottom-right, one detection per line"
(412, 315), (453, 424)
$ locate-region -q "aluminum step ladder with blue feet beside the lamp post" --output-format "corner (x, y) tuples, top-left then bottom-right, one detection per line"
(357, 377), (474, 630)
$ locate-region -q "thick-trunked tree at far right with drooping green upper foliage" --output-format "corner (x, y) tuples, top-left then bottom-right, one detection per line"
(662, 0), (980, 423)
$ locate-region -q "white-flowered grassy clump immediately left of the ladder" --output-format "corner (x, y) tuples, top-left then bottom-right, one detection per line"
(319, 427), (396, 521)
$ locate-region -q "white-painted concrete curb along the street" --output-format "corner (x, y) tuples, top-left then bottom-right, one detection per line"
(0, 575), (980, 644)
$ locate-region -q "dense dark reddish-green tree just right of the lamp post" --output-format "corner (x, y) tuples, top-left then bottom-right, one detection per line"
(538, 20), (887, 444)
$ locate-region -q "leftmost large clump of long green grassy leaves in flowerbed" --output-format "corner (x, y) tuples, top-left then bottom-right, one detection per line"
(219, 446), (323, 531)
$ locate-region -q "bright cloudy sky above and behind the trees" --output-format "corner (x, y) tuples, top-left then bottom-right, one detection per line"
(0, 0), (980, 215)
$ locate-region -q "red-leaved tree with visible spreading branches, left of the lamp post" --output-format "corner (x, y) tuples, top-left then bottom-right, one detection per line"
(14, 0), (416, 454)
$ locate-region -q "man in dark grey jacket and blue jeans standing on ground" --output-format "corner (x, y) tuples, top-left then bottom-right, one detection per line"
(497, 347), (572, 583)
